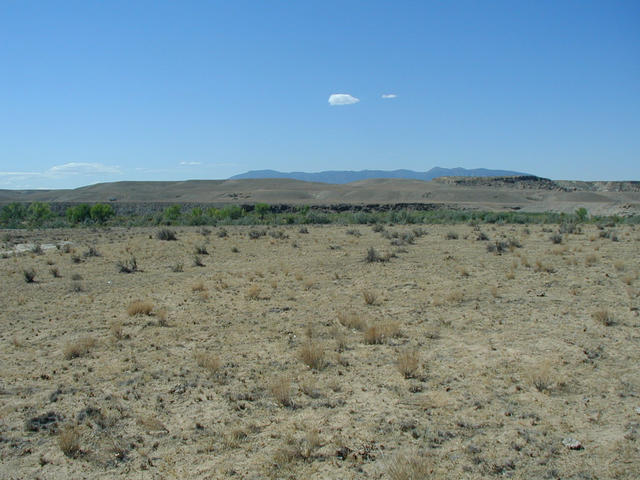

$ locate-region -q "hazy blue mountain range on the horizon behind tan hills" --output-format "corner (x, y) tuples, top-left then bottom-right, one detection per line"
(230, 167), (530, 184)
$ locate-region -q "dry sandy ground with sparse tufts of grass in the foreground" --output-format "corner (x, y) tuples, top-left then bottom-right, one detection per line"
(0, 225), (640, 480)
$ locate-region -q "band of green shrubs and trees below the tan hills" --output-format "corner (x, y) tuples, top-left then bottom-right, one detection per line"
(0, 202), (640, 228)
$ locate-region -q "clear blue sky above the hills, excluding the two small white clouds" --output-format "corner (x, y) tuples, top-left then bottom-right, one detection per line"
(0, 0), (640, 188)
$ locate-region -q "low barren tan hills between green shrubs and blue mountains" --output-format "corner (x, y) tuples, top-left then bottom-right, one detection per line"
(0, 176), (640, 214)
